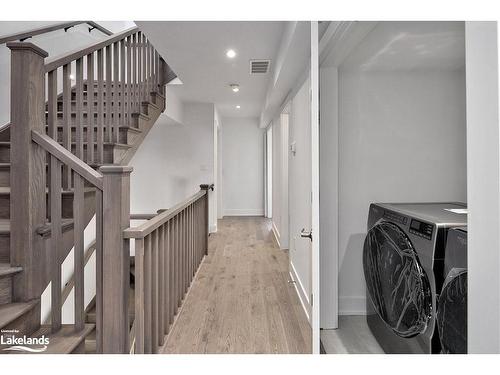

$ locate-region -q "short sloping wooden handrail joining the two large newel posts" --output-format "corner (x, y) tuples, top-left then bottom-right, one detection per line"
(31, 130), (103, 190)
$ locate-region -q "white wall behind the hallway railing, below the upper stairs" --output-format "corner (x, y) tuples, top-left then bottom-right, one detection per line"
(130, 103), (215, 227)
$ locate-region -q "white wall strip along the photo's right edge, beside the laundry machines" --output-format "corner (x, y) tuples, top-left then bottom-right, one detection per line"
(465, 22), (500, 353)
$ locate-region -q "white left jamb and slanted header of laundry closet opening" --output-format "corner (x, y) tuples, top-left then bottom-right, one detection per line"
(318, 21), (378, 329)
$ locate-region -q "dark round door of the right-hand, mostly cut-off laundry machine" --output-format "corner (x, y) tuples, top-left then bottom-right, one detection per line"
(436, 268), (467, 354)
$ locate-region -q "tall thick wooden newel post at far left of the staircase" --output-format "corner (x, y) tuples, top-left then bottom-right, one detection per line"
(7, 42), (48, 301)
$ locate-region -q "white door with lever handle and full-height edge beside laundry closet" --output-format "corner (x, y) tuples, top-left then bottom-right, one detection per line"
(289, 22), (320, 353)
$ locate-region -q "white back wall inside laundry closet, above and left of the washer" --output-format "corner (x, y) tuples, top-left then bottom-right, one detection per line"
(338, 69), (466, 314)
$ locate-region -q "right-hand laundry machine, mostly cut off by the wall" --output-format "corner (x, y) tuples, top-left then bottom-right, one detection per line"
(436, 228), (467, 354)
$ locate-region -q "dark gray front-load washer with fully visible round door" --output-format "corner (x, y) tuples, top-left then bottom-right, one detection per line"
(363, 203), (467, 353)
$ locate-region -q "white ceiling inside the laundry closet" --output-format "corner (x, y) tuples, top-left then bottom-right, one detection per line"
(342, 21), (465, 71)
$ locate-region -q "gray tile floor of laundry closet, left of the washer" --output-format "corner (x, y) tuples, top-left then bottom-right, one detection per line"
(321, 315), (384, 354)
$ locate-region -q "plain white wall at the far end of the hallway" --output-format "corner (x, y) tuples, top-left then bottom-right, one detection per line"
(221, 117), (265, 216)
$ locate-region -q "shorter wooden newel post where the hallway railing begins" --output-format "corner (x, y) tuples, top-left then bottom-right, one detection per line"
(99, 165), (133, 353)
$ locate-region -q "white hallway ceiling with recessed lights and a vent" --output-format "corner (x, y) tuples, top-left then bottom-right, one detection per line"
(136, 21), (286, 117)
